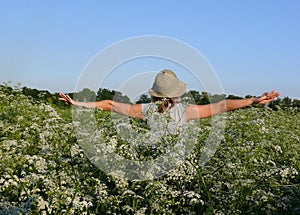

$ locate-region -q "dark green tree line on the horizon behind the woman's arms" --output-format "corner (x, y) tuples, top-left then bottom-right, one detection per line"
(4, 84), (300, 111)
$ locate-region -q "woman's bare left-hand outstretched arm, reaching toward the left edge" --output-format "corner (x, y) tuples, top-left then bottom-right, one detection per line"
(59, 93), (143, 119)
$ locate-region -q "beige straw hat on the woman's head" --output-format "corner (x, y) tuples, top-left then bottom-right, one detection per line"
(149, 69), (186, 98)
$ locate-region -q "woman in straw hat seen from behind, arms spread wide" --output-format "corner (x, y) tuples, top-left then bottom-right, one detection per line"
(60, 70), (279, 125)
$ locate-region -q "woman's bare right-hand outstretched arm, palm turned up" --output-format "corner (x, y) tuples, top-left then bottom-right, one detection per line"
(185, 90), (280, 121)
